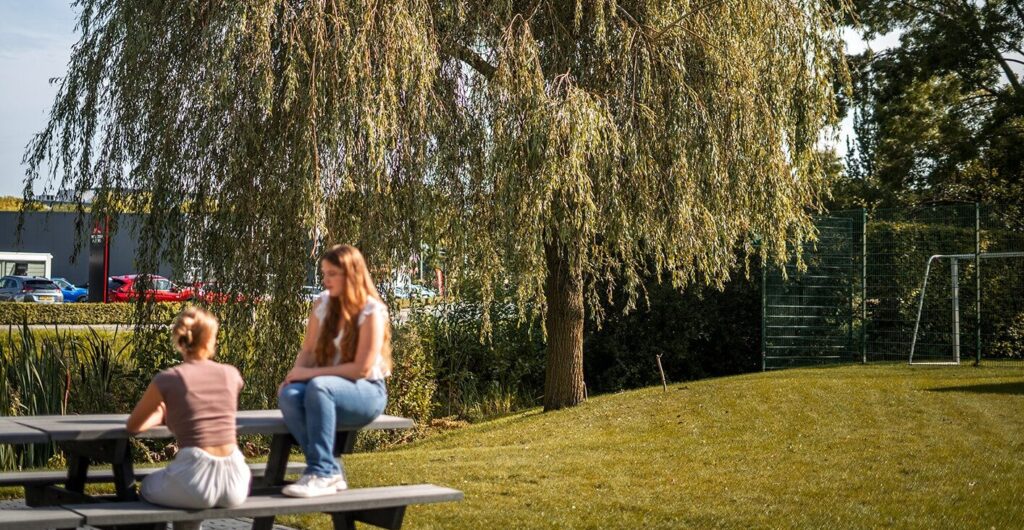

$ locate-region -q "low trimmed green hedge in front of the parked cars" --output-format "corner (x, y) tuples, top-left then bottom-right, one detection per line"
(0, 302), (181, 325)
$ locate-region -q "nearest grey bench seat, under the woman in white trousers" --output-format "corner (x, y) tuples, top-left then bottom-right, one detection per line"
(65, 484), (463, 526)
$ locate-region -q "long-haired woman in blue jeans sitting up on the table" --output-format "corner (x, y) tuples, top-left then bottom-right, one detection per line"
(278, 245), (391, 497)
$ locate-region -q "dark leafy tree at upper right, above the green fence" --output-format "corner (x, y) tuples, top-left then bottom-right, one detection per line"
(839, 0), (1024, 212)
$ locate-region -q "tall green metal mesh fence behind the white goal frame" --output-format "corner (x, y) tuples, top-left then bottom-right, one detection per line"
(762, 205), (1024, 369)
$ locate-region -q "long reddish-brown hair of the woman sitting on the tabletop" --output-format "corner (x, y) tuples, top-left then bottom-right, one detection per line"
(315, 245), (391, 370)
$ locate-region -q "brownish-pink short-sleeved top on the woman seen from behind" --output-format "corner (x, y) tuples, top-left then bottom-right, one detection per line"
(153, 360), (245, 447)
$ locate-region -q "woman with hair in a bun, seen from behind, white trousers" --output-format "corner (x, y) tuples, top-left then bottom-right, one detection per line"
(126, 307), (251, 529)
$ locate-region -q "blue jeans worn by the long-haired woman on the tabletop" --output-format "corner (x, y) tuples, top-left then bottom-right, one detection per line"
(278, 376), (387, 477)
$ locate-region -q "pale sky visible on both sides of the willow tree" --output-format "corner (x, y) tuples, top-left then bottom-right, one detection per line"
(0, 0), (897, 196)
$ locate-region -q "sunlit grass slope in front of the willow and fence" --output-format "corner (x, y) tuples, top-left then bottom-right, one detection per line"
(281, 365), (1024, 529)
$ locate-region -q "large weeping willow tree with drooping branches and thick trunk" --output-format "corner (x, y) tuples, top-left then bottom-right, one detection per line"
(26, 0), (843, 409)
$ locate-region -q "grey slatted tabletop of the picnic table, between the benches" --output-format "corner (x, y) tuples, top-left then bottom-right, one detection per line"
(0, 409), (413, 444)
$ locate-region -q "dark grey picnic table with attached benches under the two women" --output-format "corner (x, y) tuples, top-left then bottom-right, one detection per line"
(0, 410), (462, 530)
